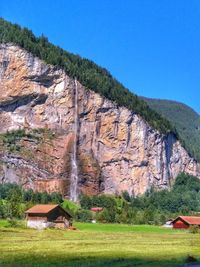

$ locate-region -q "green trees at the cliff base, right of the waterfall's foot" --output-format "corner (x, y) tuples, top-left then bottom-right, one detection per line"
(77, 173), (200, 224)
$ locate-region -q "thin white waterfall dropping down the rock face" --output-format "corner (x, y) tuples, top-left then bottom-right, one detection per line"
(70, 78), (78, 202)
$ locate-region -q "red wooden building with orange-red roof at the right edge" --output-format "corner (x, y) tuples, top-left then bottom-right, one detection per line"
(172, 216), (200, 229)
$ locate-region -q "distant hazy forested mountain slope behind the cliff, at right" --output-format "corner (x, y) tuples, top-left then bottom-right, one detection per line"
(142, 97), (200, 161)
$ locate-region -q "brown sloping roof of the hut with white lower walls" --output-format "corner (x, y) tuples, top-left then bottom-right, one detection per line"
(25, 204), (72, 217)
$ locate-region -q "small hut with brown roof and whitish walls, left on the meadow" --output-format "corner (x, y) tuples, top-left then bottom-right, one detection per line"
(25, 204), (72, 229)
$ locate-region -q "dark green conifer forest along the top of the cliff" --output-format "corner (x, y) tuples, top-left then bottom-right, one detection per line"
(0, 19), (175, 134)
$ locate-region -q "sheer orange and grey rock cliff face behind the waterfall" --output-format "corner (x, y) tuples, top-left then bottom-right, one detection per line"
(0, 44), (200, 196)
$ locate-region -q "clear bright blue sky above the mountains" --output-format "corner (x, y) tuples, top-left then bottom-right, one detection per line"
(0, 0), (200, 113)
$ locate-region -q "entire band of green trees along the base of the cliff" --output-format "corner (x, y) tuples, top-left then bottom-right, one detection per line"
(0, 173), (200, 225)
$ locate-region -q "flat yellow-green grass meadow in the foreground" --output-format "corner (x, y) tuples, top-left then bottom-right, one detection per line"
(0, 221), (200, 267)
